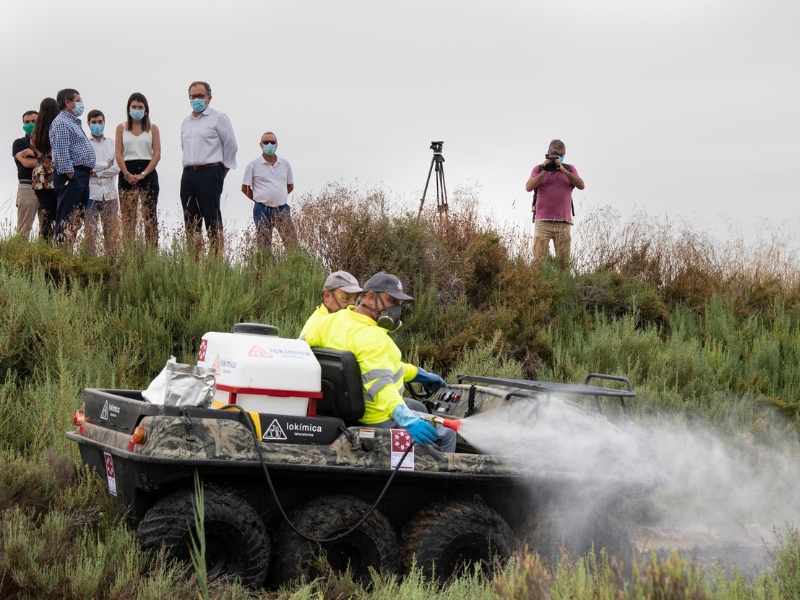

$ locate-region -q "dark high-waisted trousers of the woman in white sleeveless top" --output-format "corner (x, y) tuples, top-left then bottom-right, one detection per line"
(119, 160), (160, 246)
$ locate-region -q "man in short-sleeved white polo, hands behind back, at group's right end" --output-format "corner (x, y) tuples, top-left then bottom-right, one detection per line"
(242, 131), (297, 249)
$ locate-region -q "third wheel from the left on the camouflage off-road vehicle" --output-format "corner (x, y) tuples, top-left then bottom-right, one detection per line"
(402, 501), (516, 581)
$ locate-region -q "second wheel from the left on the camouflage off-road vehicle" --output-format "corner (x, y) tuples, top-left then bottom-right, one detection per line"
(276, 496), (400, 585)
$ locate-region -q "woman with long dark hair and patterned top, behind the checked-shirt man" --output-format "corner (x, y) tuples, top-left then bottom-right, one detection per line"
(31, 98), (60, 242)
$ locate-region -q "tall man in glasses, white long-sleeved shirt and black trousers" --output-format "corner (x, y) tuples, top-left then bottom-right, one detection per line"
(180, 81), (238, 250)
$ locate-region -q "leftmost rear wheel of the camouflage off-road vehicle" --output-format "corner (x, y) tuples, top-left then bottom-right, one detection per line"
(136, 488), (270, 587)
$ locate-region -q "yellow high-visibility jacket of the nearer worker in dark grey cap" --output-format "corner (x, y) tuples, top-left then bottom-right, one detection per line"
(305, 306), (406, 425)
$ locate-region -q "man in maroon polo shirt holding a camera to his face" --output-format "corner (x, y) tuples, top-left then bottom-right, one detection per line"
(525, 140), (584, 267)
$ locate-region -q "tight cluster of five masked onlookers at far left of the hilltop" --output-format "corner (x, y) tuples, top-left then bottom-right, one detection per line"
(12, 88), (161, 251)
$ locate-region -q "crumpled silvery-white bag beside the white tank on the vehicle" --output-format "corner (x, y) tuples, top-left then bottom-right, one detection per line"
(142, 356), (216, 408)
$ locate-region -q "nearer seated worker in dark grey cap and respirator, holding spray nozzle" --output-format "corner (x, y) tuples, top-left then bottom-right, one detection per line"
(305, 271), (456, 452)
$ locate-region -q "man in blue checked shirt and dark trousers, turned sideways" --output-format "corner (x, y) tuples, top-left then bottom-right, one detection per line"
(49, 88), (96, 245)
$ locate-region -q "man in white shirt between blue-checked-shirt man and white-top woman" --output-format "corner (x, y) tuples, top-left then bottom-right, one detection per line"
(86, 109), (119, 254)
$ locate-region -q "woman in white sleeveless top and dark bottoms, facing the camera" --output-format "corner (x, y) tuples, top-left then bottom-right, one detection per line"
(115, 92), (161, 246)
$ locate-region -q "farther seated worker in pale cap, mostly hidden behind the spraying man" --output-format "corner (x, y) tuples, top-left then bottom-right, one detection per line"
(299, 271), (444, 398)
